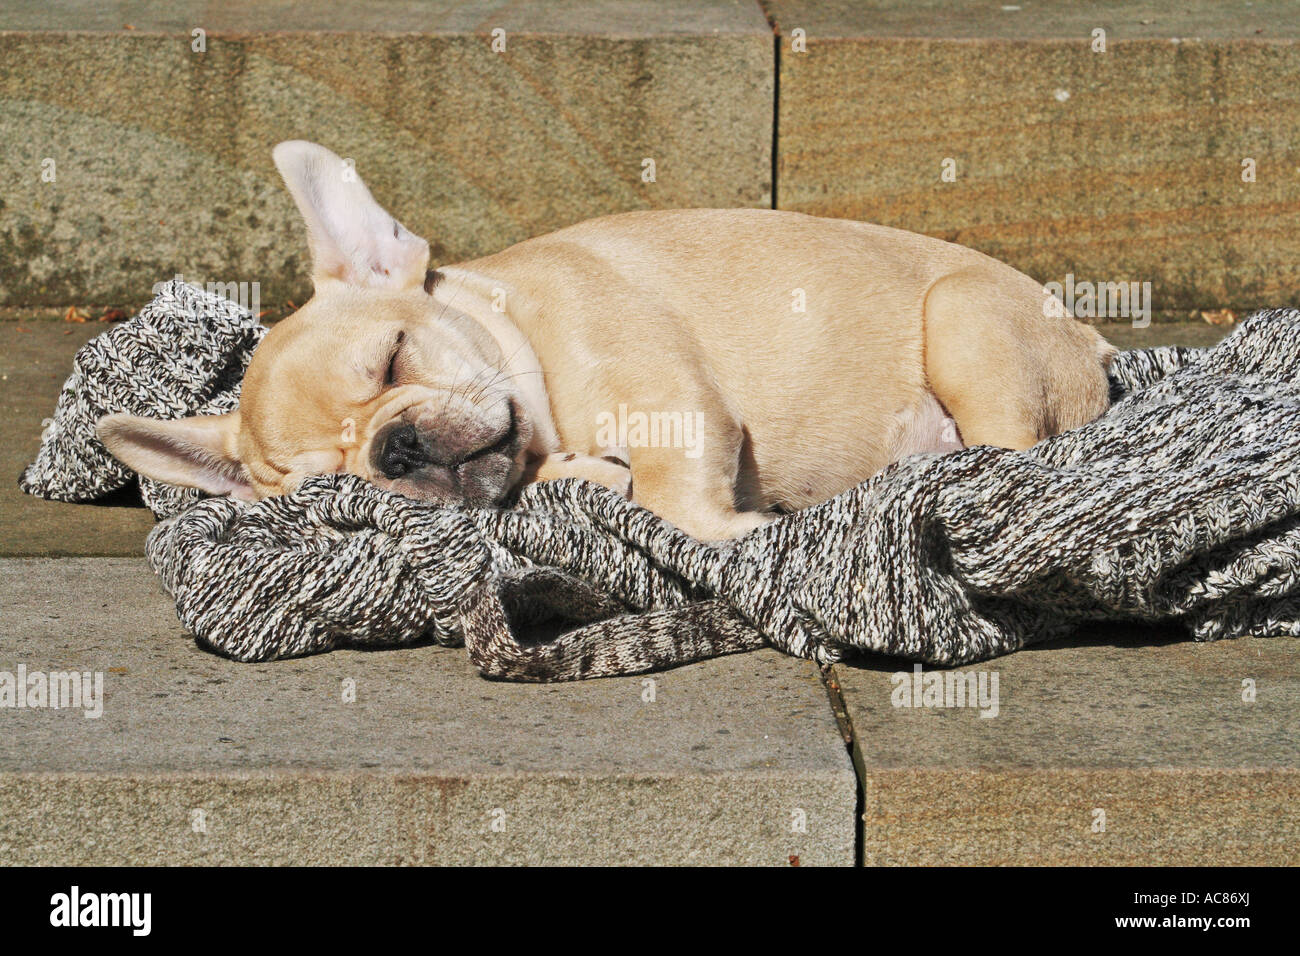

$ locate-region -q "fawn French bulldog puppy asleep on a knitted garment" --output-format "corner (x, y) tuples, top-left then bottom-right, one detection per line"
(99, 142), (1114, 538)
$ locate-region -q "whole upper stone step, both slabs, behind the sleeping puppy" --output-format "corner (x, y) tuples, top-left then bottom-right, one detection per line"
(0, 0), (1300, 317)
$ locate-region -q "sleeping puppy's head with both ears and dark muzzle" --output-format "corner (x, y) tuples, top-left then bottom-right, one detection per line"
(98, 142), (533, 505)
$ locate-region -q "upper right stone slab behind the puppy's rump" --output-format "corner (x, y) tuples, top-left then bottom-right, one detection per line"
(767, 0), (1300, 313)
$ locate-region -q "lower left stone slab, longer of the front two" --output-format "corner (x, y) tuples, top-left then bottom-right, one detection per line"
(0, 558), (855, 866)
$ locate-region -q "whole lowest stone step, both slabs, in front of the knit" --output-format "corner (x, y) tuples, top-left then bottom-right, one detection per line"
(0, 558), (1300, 865)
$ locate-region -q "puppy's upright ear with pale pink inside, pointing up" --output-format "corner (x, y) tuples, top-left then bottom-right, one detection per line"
(272, 139), (429, 289)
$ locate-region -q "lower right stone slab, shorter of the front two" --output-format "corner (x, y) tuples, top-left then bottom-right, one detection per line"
(835, 627), (1300, 866)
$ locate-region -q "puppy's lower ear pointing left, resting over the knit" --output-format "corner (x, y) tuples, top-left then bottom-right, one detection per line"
(95, 411), (256, 501)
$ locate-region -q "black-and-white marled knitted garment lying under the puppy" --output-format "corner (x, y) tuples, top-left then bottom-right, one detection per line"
(23, 282), (1300, 680)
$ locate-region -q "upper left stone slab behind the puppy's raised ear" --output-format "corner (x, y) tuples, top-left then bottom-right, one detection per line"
(0, 0), (775, 310)
